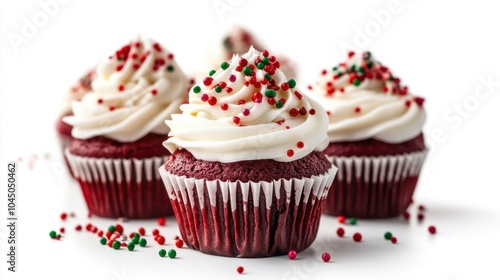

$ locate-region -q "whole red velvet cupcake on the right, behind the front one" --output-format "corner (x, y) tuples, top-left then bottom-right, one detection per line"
(310, 52), (426, 218)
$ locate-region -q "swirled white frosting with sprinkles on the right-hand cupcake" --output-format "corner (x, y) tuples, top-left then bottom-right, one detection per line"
(309, 52), (426, 143)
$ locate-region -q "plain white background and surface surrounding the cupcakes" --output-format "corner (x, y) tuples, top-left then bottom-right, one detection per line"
(0, 0), (500, 280)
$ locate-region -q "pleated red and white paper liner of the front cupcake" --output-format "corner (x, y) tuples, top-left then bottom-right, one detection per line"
(160, 166), (337, 257)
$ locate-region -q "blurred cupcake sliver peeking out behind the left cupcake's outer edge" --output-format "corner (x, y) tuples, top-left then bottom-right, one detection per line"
(55, 69), (95, 176)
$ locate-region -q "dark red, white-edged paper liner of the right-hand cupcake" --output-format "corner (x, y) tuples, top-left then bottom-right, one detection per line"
(324, 150), (427, 218)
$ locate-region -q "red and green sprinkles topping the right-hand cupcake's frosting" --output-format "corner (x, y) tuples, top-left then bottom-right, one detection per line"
(314, 51), (424, 108)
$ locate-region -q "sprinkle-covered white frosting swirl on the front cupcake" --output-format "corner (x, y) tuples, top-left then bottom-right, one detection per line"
(164, 47), (328, 162)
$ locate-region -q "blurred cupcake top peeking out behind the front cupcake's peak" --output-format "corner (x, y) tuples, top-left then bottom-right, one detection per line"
(207, 26), (297, 77)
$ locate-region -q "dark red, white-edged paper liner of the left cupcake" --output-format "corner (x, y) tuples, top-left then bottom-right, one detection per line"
(65, 149), (173, 219)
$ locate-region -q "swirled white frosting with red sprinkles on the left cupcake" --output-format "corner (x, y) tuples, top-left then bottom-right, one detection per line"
(63, 39), (188, 142)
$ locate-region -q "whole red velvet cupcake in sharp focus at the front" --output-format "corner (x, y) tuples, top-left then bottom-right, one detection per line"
(160, 48), (336, 257)
